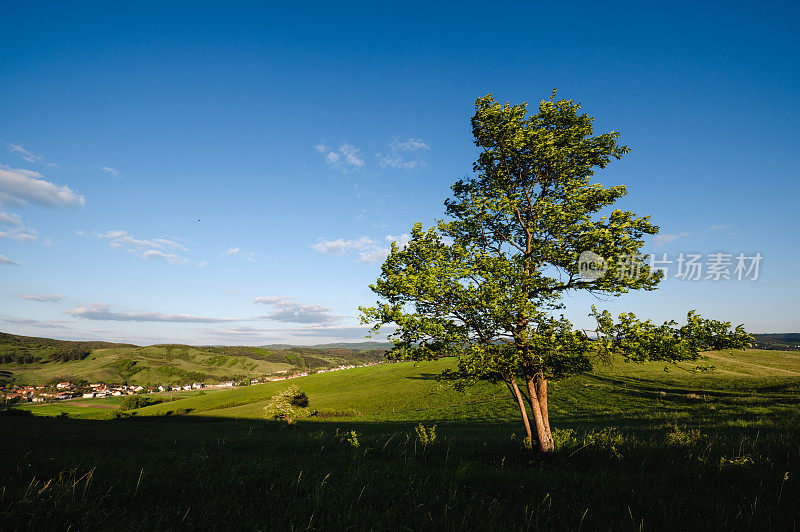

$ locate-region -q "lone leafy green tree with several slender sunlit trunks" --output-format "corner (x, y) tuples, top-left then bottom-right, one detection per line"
(361, 91), (751, 452)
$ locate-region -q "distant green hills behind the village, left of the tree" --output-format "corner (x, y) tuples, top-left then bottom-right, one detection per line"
(0, 333), (385, 385)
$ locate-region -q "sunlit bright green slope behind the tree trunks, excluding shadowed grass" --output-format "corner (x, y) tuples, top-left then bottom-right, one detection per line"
(15, 350), (800, 424)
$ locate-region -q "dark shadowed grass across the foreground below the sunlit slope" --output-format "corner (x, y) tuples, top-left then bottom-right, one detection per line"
(0, 416), (800, 530)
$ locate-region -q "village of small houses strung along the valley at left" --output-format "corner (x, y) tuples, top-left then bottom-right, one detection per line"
(0, 362), (383, 404)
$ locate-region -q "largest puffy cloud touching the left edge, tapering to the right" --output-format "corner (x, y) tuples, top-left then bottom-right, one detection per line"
(0, 165), (86, 208)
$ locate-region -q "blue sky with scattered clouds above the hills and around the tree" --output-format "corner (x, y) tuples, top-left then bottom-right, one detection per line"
(0, 2), (800, 345)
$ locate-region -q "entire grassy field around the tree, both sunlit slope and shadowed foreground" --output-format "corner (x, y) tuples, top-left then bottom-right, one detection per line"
(0, 351), (800, 530)
